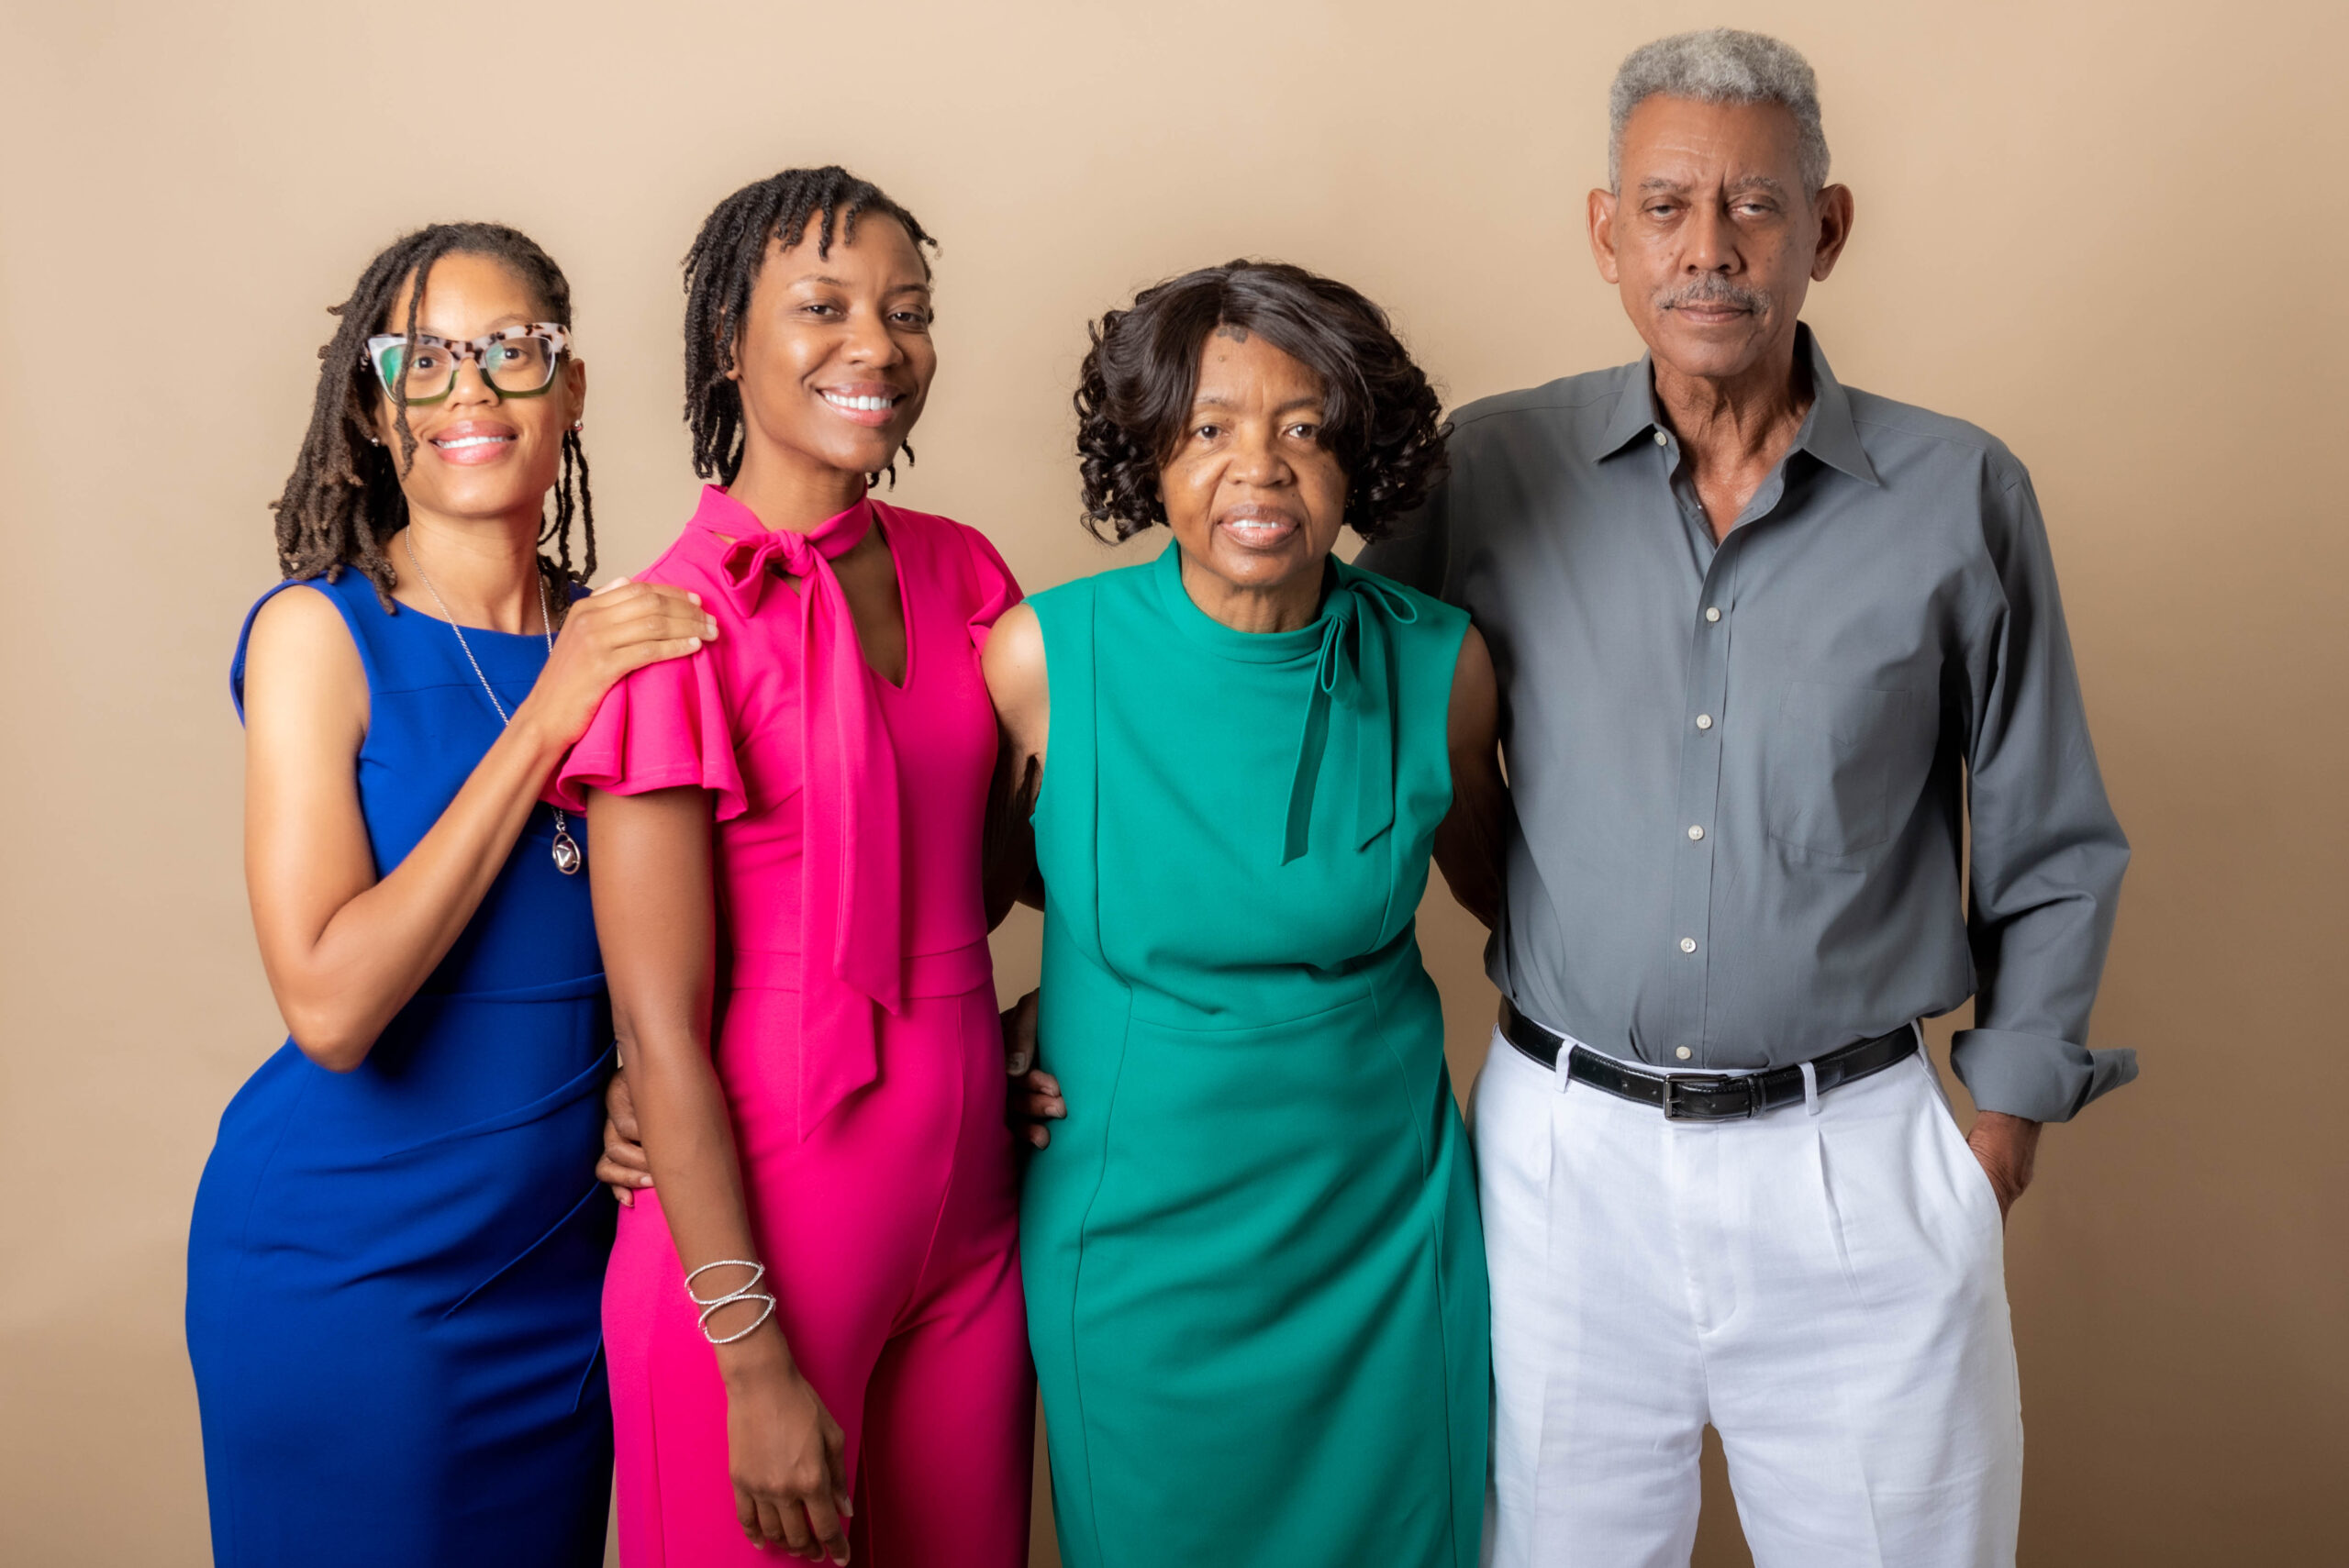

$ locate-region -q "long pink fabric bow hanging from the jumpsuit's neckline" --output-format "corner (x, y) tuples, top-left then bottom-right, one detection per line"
(705, 495), (905, 1139)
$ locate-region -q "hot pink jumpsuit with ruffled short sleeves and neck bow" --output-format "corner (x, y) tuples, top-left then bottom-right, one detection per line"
(550, 486), (1036, 1568)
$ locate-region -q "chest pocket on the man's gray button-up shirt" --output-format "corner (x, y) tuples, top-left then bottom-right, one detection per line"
(1762, 681), (1933, 857)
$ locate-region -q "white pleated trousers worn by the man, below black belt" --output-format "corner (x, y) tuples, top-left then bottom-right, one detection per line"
(1475, 1033), (2022, 1568)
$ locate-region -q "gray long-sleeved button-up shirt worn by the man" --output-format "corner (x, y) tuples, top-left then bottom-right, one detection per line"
(1363, 327), (2138, 1122)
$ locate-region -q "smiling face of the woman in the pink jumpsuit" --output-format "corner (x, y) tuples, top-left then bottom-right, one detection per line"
(729, 214), (937, 505)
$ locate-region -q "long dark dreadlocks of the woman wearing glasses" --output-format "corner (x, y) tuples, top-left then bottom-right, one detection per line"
(270, 223), (595, 617)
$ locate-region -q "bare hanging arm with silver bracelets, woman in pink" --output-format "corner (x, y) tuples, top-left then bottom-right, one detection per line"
(587, 789), (851, 1561)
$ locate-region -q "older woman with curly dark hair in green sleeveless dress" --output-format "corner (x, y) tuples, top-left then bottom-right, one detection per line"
(985, 263), (1508, 1568)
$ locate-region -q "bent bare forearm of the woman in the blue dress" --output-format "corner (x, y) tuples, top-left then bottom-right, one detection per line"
(262, 723), (562, 1071)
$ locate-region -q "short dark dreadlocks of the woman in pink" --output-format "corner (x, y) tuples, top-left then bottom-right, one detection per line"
(686, 164), (937, 484)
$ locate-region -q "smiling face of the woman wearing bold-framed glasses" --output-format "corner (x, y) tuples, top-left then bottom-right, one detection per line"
(376, 251), (587, 535)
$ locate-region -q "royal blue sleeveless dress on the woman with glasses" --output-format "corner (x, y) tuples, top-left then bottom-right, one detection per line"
(188, 571), (613, 1568)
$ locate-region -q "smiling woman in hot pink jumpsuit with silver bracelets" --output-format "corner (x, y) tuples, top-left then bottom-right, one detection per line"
(554, 169), (1033, 1568)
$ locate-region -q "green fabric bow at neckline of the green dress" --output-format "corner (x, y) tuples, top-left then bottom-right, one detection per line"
(1280, 566), (1419, 866)
